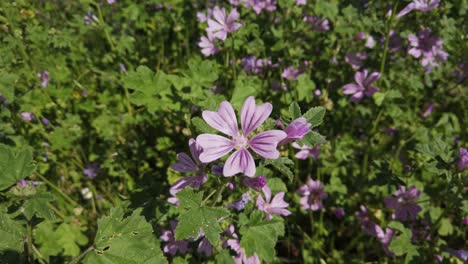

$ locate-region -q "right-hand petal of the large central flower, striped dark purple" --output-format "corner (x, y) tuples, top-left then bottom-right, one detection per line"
(249, 130), (287, 159)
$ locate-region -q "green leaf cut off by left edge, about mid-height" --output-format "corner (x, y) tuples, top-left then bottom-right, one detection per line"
(0, 145), (36, 191)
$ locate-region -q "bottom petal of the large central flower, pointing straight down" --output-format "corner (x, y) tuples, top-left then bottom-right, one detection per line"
(223, 148), (255, 177)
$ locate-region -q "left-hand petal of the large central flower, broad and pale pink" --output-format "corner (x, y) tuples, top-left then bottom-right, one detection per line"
(197, 134), (235, 163)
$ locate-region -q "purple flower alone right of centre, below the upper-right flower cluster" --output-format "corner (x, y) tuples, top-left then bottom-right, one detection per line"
(343, 70), (381, 102)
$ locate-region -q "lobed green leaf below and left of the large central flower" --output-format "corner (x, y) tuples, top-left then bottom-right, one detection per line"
(176, 189), (229, 245)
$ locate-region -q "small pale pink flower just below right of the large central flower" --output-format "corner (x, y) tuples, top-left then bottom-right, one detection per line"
(257, 185), (291, 219)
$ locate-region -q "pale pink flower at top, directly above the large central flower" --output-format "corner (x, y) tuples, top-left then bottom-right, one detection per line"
(206, 6), (241, 41)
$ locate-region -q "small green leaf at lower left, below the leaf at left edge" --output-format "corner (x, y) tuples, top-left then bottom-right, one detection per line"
(21, 192), (55, 221)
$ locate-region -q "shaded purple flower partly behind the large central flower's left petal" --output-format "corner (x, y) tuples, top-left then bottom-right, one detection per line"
(169, 138), (207, 196)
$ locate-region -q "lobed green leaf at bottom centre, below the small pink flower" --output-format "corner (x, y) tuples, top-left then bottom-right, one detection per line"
(239, 211), (284, 262)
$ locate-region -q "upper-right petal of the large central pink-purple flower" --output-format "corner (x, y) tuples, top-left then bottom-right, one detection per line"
(241, 96), (273, 136)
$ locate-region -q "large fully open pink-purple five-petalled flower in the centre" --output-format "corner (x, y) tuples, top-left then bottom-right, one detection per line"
(197, 96), (286, 177)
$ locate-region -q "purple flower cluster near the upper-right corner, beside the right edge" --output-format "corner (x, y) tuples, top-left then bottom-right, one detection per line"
(408, 28), (448, 72)
